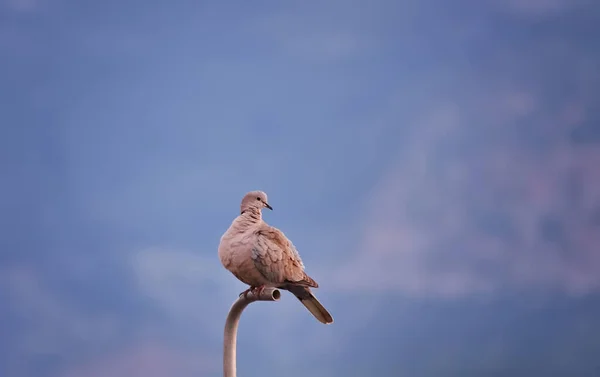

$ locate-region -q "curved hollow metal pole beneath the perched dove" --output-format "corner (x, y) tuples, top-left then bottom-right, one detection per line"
(223, 288), (281, 377)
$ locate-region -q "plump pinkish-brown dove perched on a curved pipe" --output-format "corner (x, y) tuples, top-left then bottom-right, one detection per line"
(218, 190), (333, 324)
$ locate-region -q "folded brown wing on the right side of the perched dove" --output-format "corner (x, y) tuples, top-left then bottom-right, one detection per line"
(252, 224), (319, 288)
